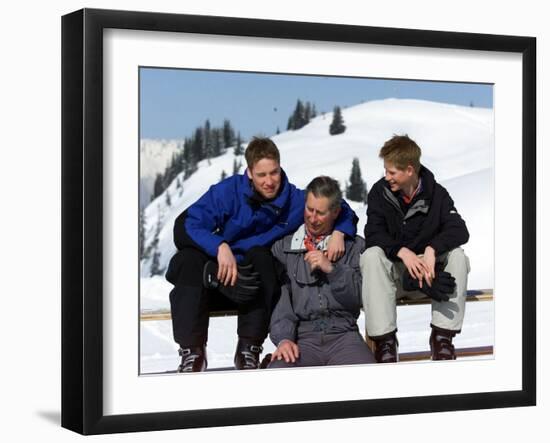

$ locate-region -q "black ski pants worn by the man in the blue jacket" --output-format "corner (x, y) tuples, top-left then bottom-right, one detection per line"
(166, 247), (280, 347)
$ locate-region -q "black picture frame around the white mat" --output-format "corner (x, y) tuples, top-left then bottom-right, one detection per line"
(62, 9), (536, 434)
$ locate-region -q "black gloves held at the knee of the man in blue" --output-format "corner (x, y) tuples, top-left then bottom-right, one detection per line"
(202, 261), (261, 304)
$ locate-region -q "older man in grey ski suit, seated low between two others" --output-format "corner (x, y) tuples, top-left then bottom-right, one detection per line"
(269, 176), (375, 368)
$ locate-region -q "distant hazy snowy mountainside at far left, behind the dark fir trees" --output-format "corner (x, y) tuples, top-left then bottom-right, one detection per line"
(139, 139), (183, 207)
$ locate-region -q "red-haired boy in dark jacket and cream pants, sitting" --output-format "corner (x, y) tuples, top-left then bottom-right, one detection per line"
(361, 135), (469, 363)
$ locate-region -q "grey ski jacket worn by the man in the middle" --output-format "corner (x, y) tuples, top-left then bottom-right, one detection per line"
(270, 225), (365, 346)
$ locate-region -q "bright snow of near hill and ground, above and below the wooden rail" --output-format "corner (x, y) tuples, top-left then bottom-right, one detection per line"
(140, 99), (494, 373)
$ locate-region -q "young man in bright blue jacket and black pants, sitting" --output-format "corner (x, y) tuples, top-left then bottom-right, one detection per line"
(166, 138), (357, 372)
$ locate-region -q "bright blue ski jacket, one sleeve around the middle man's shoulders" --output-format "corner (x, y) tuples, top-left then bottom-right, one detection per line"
(184, 170), (357, 262)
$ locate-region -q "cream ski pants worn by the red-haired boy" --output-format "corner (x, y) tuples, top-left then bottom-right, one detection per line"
(360, 246), (470, 338)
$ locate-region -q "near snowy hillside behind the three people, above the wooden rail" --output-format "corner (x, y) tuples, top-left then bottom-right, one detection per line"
(141, 99), (494, 288)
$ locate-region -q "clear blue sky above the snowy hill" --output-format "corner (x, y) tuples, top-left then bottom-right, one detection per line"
(140, 68), (493, 140)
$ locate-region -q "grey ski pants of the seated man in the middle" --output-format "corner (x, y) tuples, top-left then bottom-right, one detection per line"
(268, 331), (376, 368)
